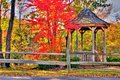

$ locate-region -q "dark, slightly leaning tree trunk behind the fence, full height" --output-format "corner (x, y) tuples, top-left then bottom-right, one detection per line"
(5, 0), (16, 68)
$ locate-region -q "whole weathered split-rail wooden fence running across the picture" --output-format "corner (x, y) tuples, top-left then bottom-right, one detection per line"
(0, 52), (120, 70)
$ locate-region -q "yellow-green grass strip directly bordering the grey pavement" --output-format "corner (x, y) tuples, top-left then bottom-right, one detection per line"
(0, 68), (120, 77)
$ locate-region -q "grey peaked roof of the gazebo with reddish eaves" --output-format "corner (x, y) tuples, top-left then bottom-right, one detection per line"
(72, 8), (109, 28)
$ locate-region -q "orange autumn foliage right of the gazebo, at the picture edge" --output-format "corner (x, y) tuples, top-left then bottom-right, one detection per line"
(107, 22), (120, 53)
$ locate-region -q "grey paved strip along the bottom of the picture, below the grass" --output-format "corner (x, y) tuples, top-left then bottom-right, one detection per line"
(0, 76), (120, 80)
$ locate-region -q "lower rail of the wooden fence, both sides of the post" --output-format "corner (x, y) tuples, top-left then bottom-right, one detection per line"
(0, 59), (120, 66)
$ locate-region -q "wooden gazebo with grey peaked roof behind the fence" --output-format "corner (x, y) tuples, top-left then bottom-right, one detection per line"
(66, 8), (110, 62)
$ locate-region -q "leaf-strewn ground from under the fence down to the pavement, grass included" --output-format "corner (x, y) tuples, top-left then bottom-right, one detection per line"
(0, 64), (120, 78)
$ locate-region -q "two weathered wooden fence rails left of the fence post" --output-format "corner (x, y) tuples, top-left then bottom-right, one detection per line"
(0, 52), (66, 65)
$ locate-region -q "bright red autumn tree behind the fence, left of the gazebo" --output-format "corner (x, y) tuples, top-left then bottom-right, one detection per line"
(27, 0), (77, 52)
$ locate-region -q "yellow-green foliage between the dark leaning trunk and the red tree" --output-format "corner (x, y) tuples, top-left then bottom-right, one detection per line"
(11, 19), (36, 52)
